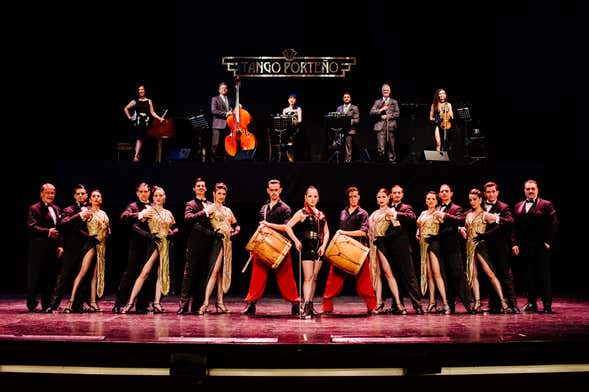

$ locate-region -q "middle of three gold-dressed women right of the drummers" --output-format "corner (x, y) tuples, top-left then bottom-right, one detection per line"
(417, 191), (450, 314)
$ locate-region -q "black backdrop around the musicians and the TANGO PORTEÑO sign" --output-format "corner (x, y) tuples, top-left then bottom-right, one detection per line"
(5, 0), (587, 291)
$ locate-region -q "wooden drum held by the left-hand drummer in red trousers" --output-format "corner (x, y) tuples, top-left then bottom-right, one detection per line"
(245, 226), (291, 269)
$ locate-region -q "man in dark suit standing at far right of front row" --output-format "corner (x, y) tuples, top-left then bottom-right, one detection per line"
(511, 180), (558, 313)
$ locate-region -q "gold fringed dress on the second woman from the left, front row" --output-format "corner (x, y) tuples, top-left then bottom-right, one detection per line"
(147, 206), (176, 295)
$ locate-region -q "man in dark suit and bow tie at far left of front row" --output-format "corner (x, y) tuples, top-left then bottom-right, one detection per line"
(27, 183), (63, 312)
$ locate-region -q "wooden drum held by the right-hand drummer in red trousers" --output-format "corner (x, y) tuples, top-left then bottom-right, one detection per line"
(325, 233), (369, 275)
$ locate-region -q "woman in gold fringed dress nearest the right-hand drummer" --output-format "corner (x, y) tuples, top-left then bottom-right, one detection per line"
(368, 188), (407, 314)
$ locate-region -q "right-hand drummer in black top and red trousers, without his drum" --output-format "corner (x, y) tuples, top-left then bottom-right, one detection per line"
(322, 186), (378, 314)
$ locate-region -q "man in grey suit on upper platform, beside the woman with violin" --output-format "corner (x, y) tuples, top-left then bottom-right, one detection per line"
(370, 83), (399, 164)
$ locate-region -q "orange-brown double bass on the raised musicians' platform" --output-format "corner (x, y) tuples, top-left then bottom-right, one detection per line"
(225, 76), (256, 157)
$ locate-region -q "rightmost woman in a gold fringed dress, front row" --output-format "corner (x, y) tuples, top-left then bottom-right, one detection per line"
(460, 188), (509, 313)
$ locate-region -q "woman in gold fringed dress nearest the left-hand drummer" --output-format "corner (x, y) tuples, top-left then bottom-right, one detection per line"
(197, 182), (240, 315)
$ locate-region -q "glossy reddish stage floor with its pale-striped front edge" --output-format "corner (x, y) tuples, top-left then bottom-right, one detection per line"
(0, 296), (589, 385)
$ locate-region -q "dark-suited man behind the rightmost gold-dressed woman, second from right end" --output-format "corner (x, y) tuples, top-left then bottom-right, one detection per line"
(479, 182), (520, 314)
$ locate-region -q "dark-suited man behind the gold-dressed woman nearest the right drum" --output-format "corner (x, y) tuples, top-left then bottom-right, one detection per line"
(384, 185), (424, 314)
